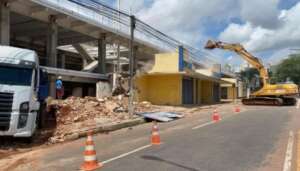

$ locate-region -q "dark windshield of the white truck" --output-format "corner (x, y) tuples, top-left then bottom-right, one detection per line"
(0, 66), (32, 86)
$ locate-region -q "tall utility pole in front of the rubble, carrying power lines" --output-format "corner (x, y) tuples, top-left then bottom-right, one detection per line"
(128, 15), (135, 116)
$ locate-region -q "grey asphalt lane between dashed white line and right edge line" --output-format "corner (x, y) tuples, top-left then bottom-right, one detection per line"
(103, 107), (292, 171)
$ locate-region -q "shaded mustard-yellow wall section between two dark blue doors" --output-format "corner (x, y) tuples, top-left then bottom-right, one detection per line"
(201, 80), (213, 104)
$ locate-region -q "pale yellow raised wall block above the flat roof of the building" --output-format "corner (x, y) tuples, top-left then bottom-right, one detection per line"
(149, 52), (179, 73)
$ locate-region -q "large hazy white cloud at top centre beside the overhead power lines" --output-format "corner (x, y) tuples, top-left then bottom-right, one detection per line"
(137, 0), (235, 46)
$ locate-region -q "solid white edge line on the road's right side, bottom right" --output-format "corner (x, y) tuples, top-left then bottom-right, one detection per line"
(283, 131), (294, 171)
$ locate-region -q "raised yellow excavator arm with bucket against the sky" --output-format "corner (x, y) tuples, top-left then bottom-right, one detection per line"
(205, 40), (269, 85)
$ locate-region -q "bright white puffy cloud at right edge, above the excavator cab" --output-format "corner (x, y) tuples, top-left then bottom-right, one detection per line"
(219, 2), (300, 51)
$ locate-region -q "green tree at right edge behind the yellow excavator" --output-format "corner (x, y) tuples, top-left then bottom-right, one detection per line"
(274, 54), (300, 85)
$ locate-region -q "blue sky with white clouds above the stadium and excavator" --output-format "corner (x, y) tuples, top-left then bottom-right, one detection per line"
(99, 0), (300, 70)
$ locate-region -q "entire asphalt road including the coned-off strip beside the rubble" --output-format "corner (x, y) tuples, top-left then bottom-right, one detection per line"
(0, 106), (299, 171)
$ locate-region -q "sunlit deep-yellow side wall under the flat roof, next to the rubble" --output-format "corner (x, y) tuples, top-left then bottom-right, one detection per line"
(136, 74), (182, 105)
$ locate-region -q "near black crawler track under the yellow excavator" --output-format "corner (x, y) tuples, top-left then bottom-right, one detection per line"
(242, 97), (284, 106)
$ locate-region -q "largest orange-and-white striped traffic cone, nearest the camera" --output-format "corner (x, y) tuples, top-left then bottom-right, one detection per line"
(80, 132), (102, 171)
